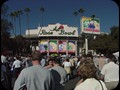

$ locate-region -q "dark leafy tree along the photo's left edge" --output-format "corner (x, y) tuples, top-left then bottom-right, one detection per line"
(1, 4), (12, 51)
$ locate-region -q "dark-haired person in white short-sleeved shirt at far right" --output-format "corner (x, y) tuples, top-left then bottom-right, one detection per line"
(100, 55), (119, 90)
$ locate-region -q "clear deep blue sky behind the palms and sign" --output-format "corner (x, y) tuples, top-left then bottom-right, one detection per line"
(5, 0), (119, 34)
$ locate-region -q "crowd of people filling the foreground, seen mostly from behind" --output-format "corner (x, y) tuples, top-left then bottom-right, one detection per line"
(1, 50), (119, 90)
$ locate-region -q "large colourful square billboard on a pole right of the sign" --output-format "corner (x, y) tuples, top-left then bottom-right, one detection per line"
(81, 17), (100, 34)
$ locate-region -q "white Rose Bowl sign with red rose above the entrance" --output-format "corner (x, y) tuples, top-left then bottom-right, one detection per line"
(38, 23), (78, 37)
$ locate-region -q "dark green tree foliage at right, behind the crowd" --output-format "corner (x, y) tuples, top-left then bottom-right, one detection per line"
(89, 26), (119, 53)
